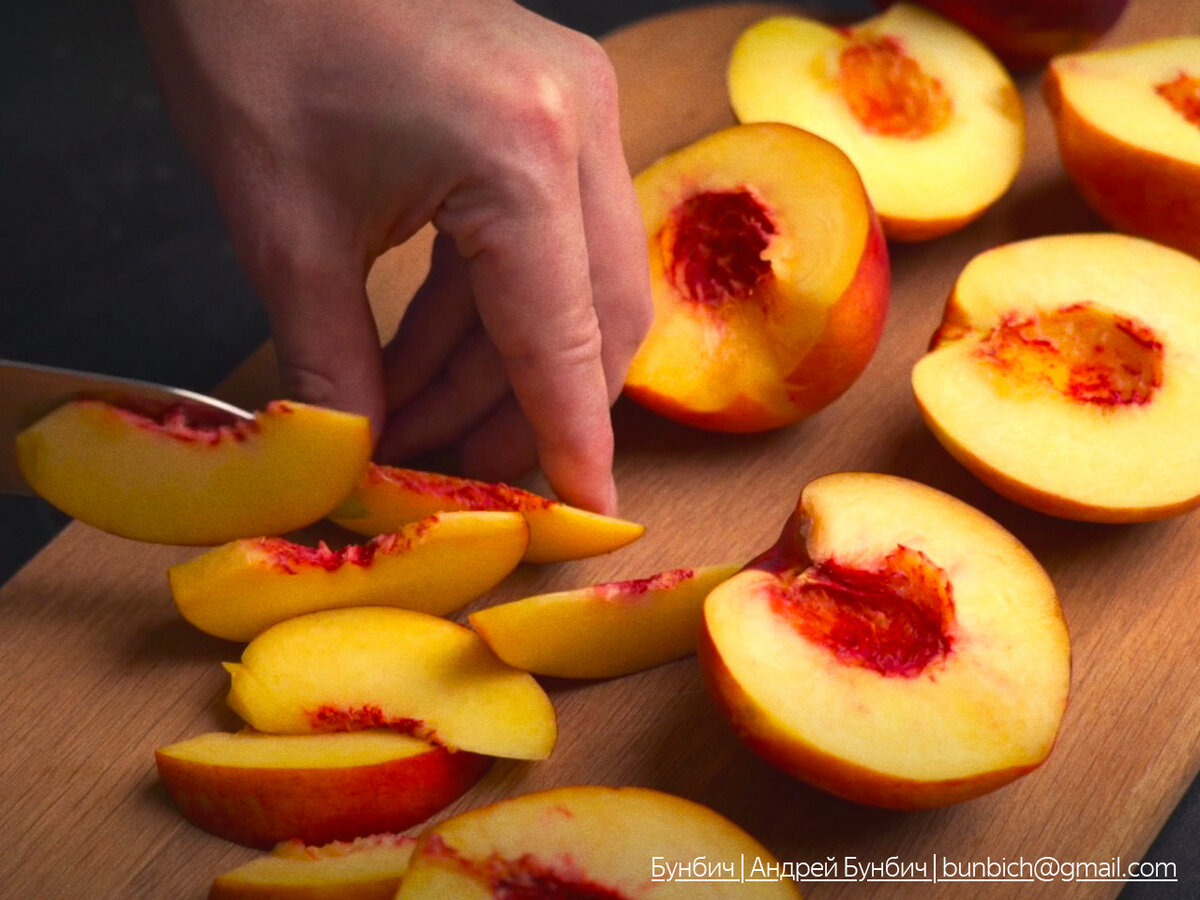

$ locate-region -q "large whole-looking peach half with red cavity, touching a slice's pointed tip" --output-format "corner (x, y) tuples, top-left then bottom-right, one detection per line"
(700, 473), (1070, 809)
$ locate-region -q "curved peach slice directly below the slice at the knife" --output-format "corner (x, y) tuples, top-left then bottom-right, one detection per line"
(167, 512), (529, 641)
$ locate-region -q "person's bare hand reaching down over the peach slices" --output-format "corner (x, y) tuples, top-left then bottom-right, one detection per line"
(139, 0), (652, 512)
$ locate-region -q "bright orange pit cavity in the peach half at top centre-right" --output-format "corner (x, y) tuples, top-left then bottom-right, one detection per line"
(838, 36), (950, 139)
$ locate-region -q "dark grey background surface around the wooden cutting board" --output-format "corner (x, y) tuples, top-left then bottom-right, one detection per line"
(0, 0), (1200, 900)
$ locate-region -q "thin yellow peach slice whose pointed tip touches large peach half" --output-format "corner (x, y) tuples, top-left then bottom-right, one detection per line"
(470, 565), (742, 678)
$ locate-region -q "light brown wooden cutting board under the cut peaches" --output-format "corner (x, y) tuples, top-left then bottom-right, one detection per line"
(0, 0), (1200, 898)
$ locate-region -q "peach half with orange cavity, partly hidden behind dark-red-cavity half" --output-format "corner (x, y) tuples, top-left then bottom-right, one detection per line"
(728, 4), (1025, 241)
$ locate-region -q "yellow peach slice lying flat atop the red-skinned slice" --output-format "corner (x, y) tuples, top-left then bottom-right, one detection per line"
(224, 606), (557, 760)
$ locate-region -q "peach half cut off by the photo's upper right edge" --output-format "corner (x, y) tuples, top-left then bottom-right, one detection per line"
(1043, 35), (1200, 257)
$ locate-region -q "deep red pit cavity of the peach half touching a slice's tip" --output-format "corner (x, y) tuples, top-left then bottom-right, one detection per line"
(773, 546), (954, 678)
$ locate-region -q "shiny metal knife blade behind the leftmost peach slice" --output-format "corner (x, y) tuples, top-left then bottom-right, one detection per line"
(0, 359), (254, 494)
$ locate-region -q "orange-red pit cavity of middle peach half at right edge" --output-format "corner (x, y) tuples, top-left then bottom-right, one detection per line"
(976, 302), (1163, 408)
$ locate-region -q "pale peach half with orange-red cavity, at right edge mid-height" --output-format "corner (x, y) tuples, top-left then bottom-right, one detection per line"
(912, 234), (1200, 522)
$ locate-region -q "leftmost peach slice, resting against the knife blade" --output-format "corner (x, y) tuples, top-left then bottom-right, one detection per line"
(17, 400), (371, 544)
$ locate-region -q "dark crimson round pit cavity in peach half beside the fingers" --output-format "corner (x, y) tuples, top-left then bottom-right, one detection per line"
(659, 187), (778, 306)
